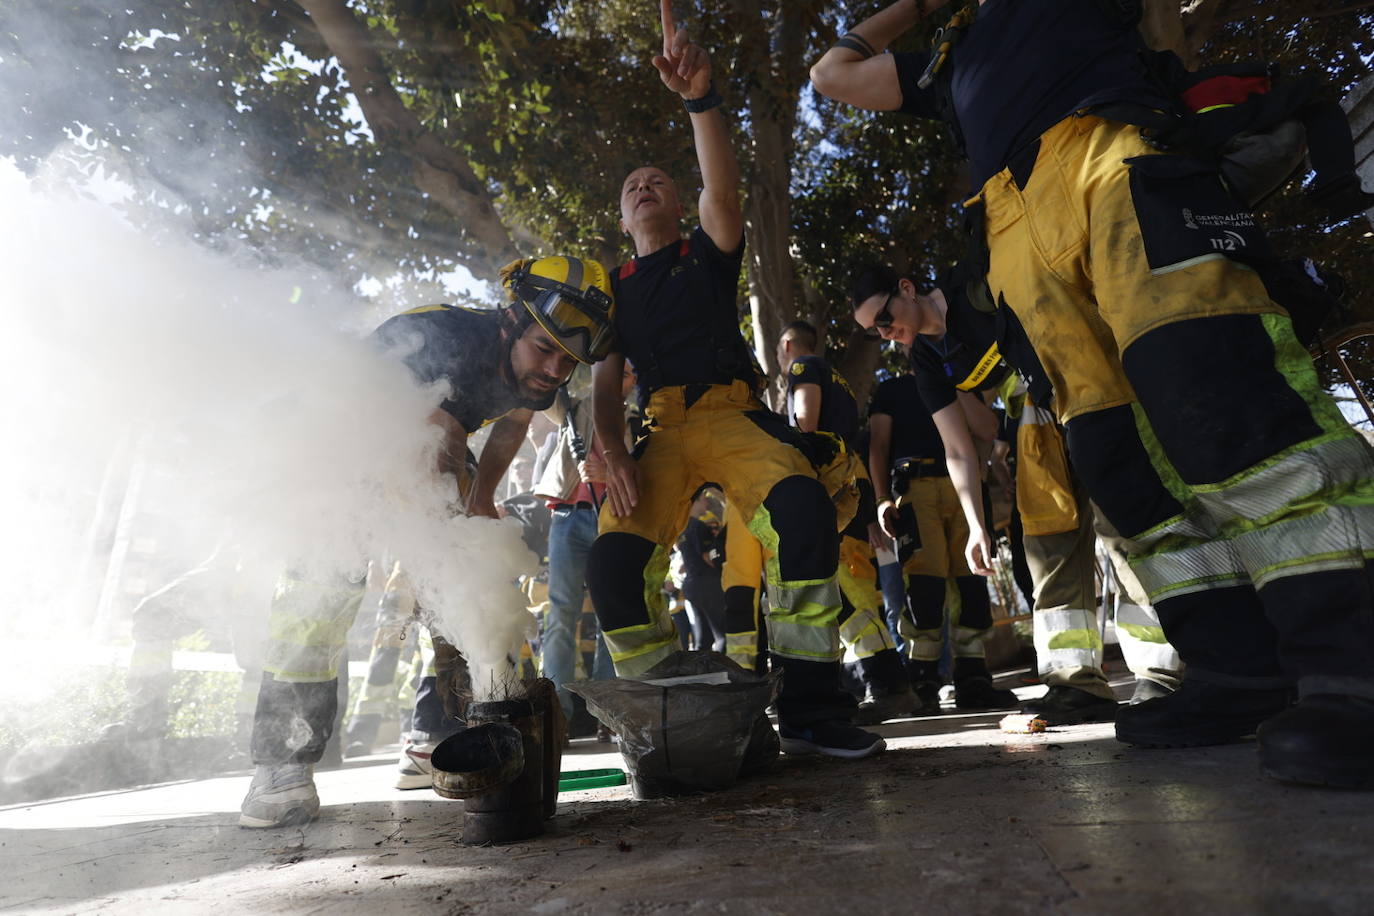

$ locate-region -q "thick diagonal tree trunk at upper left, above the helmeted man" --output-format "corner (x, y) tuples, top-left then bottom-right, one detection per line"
(297, 0), (518, 279)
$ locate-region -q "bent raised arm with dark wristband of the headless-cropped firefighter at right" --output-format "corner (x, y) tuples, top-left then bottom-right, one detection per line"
(811, 0), (949, 111)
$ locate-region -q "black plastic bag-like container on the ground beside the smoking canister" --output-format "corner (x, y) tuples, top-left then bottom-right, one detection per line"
(567, 652), (782, 798)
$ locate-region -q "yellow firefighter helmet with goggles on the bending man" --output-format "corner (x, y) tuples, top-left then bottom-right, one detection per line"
(500, 257), (616, 364)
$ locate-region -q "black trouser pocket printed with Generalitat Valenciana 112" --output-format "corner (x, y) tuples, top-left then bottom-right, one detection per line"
(1125, 155), (1270, 273)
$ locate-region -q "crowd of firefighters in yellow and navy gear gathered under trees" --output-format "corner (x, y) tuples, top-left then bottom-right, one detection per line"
(188, 0), (1374, 827)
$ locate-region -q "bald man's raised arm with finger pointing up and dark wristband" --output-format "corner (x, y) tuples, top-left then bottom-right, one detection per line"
(654, 0), (745, 253)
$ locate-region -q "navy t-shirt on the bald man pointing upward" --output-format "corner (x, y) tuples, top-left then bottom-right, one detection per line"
(611, 227), (753, 398)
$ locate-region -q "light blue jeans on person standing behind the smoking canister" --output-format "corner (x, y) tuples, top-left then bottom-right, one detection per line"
(540, 507), (616, 715)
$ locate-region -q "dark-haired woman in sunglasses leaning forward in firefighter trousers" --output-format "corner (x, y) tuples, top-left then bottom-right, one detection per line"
(853, 260), (1182, 725)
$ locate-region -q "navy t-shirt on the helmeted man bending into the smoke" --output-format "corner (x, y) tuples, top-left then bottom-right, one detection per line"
(372, 305), (556, 433)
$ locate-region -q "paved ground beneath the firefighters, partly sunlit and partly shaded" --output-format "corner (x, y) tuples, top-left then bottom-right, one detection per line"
(0, 715), (1374, 916)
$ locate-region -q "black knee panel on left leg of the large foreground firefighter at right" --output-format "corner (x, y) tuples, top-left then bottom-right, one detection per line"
(1065, 404), (1183, 537)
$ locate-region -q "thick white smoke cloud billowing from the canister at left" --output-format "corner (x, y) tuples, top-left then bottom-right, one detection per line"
(0, 161), (533, 703)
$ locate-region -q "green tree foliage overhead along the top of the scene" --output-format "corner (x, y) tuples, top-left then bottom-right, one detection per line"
(0, 0), (1374, 398)
